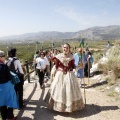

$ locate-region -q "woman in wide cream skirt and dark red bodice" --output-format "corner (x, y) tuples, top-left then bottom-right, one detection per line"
(45, 43), (84, 112)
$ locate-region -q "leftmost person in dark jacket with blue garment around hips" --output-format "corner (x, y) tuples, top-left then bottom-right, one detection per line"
(0, 50), (19, 120)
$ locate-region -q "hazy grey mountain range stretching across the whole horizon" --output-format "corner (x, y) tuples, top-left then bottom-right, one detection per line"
(0, 25), (120, 42)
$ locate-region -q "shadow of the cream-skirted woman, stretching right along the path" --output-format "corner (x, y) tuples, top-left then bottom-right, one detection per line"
(44, 104), (119, 120)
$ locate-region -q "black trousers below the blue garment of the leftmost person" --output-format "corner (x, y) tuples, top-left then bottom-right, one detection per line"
(0, 106), (14, 120)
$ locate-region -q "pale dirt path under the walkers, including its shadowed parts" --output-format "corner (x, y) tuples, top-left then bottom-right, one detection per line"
(15, 80), (120, 120)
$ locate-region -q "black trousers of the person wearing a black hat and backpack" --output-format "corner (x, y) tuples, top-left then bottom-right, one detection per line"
(15, 76), (24, 108)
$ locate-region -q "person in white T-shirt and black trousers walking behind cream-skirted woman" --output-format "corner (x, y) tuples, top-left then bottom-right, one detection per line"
(35, 52), (48, 89)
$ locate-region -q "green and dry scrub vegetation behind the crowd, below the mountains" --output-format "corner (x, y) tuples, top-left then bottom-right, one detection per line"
(0, 40), (120, 81)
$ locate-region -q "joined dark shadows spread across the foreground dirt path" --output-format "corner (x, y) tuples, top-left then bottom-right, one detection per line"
(15, 84), (119, 120)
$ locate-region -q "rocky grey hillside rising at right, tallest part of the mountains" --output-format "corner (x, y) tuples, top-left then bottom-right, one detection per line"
(74, 26), (120, 40)
